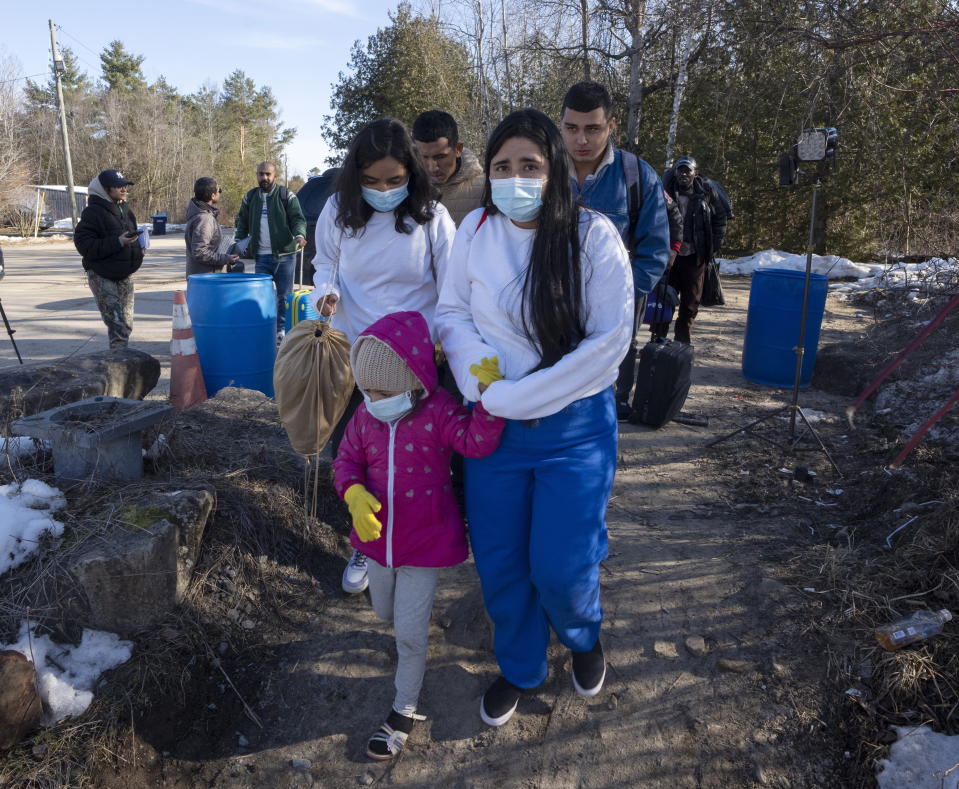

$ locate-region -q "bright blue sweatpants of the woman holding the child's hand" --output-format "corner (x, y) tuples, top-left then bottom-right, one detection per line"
(466, 388), (617, 688)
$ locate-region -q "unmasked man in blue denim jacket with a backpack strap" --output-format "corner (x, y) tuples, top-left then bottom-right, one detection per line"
(560, 82), (670, 419)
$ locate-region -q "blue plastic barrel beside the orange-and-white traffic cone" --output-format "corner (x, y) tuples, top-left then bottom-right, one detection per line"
(186, 274), (276, 397)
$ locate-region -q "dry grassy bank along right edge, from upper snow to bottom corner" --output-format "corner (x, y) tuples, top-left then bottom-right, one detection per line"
(725, 271), (959, 788)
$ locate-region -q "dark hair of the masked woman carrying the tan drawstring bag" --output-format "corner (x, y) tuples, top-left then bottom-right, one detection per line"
(334, 118), (439, 235)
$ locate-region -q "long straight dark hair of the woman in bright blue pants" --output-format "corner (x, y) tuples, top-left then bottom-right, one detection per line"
(483, 108), (586, 370)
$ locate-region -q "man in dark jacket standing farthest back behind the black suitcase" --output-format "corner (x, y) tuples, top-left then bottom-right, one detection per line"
(655, 156), (733, 344)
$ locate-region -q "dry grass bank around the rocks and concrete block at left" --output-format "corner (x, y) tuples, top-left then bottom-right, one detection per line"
(0, 390), (346, 789)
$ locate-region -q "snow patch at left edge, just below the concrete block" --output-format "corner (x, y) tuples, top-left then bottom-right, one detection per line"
(0, 479), (66, 575)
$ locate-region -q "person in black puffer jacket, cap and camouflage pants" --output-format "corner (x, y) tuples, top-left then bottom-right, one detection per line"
(73, 170), (143, 348)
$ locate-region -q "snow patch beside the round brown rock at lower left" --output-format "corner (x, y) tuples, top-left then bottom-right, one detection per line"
(0, 620), (133, 726)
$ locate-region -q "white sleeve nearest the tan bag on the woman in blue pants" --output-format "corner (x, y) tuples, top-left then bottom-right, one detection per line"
(436, 209), (497, 402)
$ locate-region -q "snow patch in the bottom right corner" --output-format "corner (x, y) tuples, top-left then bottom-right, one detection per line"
(876, 726), (959, 789)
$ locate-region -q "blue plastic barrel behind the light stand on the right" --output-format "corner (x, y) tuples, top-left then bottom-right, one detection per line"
(743, 268), (828, 388)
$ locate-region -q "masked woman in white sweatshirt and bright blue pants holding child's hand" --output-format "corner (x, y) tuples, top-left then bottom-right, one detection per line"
(436, 109), (633, 726)
